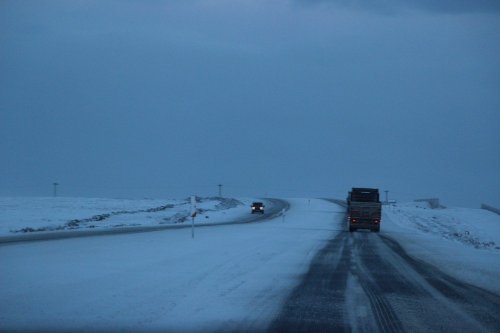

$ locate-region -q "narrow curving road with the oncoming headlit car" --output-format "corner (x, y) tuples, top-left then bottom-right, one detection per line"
(0, 198), (290, 244)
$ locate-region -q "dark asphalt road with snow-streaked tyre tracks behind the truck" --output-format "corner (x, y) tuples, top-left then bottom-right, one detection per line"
(268, 210), (500, 332)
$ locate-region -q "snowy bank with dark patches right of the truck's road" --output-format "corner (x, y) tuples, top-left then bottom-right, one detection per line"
(381, 202), (500, 293)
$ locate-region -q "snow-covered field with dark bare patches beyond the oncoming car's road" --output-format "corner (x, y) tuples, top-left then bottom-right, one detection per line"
(0, 197), (262, 236)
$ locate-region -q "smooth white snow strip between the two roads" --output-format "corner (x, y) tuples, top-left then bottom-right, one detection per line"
(0, 199), (343, 331)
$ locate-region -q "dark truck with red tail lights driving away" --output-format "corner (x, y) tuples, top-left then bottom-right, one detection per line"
(346, 187), (382, 232)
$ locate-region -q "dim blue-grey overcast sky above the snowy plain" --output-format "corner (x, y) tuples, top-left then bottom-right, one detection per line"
(0, 0), (500, 207)
